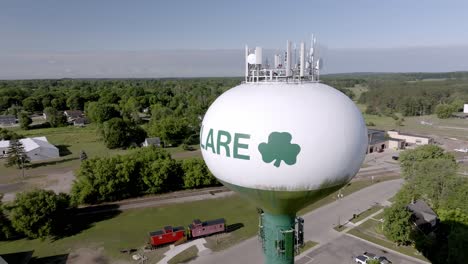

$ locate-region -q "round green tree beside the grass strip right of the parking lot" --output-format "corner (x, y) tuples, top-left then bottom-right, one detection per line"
(383, 203), (412, 245)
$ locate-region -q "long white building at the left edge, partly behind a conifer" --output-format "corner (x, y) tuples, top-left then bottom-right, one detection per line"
(0, 137), (60, 161)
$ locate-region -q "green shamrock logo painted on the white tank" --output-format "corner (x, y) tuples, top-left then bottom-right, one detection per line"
(258, 132), (301, 168)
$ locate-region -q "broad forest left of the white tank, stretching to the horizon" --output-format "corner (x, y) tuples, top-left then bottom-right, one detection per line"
(0, 78), (241, 148)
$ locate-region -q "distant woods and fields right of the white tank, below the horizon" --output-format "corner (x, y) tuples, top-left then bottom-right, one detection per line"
(322, 72), (468, 118)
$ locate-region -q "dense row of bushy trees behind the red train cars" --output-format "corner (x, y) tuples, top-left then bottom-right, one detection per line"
(71, 147), (219, 204)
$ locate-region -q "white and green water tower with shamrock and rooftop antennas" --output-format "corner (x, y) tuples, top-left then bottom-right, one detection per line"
(200, 36), (367, 264)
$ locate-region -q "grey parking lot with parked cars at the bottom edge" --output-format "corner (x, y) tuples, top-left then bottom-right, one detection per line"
(295, 235), (424, 264)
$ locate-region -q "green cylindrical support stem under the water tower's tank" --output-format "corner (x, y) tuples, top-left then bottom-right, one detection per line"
(262, 212), (296, 264)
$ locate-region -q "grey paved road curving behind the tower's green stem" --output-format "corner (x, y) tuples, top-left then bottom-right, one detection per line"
(190, 179), (403, 264)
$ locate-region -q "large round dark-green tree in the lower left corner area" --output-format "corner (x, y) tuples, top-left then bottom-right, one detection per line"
(10, 190), (70, 238)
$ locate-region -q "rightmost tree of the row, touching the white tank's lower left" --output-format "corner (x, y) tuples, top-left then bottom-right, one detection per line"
(182, 158), (219, 189)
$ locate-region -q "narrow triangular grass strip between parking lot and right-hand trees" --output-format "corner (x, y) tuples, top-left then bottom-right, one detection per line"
(348, 219), (428, 261)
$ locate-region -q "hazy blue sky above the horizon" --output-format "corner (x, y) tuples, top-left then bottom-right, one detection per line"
(0, 0), (468, 78)
